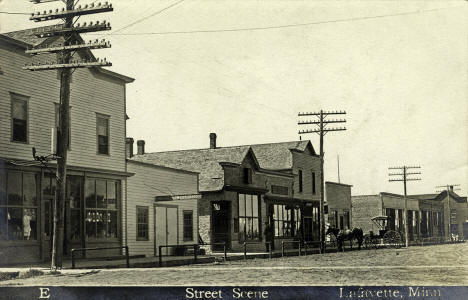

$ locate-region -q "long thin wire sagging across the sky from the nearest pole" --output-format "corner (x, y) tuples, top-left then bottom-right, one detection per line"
(99, 5), (461, 36)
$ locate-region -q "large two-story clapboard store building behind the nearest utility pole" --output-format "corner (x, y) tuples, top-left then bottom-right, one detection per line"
(0, 30), (133, 263)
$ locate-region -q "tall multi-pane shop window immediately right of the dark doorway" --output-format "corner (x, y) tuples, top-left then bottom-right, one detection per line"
(239, 194), (260, 241)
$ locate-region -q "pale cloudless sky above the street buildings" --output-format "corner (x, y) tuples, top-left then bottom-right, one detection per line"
(0, 0), (468, 195)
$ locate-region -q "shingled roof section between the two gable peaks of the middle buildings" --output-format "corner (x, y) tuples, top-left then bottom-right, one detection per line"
(252, 140), (316, 170)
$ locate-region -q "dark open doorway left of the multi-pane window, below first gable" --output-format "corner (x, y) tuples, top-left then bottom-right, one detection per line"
(211, 201), (230, 250)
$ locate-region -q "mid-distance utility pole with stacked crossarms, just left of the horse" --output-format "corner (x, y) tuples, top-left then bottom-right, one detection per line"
(297, 110), (346, 253)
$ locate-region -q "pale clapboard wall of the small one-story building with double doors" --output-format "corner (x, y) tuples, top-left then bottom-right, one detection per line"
(126, 161), (198, 256)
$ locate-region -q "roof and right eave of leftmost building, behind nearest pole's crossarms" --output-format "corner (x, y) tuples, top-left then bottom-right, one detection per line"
(0, 25), (135, 83)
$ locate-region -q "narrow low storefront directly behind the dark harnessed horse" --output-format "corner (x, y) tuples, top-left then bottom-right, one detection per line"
(325, 181), (354, 229)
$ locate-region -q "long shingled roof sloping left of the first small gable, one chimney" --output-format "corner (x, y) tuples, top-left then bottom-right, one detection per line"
(131, 146), (252, 191)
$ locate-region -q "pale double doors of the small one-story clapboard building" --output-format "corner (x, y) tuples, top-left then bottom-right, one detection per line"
(155, 206), (178, 255)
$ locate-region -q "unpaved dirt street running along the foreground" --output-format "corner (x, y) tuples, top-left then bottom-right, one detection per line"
(0, 243), (468, 286)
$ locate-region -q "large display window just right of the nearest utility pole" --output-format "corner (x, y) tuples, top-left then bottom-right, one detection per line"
(85, 178), (119, 239)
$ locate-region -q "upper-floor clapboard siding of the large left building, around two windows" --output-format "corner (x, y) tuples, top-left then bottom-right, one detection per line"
(0, 41), (125, 171)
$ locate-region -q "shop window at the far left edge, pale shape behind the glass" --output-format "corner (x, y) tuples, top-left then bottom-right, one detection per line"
(0, 169), (38, 240)
